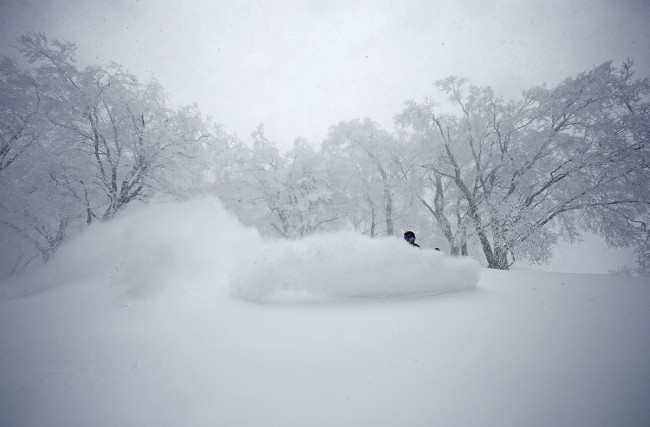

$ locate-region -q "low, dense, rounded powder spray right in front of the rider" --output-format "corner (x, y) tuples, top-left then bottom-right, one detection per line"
(231, 232), (480, 302)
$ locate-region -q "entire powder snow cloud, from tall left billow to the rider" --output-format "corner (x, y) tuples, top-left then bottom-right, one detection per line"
(2, 198), (480, 302)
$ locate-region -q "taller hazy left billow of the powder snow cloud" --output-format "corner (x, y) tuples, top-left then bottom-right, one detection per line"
(5, 197), (262, 297)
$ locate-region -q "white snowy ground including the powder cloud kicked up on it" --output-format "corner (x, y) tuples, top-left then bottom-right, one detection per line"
(0, 200), (650, 427)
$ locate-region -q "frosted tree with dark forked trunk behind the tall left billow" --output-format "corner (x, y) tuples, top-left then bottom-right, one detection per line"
(20, 34), (196, 220)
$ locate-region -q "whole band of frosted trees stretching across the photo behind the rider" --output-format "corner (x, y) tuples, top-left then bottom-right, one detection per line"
(0, 33), (650, 277)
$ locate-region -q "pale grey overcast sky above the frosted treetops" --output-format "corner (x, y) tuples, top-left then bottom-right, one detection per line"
(0, 0), (650, 148)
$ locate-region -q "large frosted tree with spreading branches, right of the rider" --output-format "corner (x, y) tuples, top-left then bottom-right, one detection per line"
(401, 63), (649, 269)
